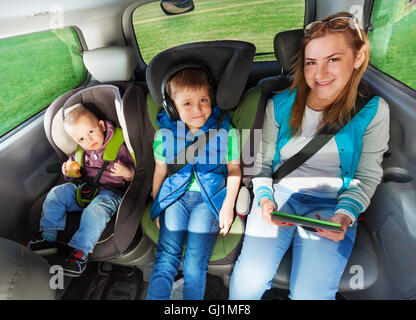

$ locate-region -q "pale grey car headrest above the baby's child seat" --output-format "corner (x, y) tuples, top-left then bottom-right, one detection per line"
(82, 46), (138, 82)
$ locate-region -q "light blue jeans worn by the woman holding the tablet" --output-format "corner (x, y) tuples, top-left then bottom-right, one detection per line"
(229, 185), (357, 300)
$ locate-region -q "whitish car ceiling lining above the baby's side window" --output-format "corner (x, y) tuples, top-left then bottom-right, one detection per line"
(0, 0), (141, 49)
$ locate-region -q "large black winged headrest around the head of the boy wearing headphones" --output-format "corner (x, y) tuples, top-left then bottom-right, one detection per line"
(146, 40), (256, 110)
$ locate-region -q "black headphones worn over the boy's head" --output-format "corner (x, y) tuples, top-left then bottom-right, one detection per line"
(161, 63), (215, 121)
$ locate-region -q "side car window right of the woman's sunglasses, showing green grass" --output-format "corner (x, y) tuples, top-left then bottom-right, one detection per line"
(369, 0), (416, 89)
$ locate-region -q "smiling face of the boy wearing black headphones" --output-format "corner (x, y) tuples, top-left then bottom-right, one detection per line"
(172, 87), (211, 131)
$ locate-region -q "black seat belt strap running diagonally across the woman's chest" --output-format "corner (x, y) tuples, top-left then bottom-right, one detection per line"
(272, 92), (373, 184)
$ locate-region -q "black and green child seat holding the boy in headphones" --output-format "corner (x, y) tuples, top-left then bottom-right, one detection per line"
(142, 41), (265, 281)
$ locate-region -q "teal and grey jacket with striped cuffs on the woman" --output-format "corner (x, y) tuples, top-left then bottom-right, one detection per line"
(253, 89), (389, 221)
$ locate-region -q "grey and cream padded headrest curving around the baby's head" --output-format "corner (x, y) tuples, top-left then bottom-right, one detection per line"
(49, 84), (121, 154)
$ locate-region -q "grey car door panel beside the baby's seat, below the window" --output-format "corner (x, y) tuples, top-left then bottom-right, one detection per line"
(0, 116), (60, 241)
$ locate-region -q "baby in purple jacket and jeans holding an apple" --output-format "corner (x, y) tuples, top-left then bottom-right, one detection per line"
(26, 104), (134, 277)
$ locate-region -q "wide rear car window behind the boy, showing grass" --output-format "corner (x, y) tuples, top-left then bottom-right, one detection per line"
(133, 0), (305, 63)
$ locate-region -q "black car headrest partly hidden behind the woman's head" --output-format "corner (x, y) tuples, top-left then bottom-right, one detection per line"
(274, 29), (304, 74)
